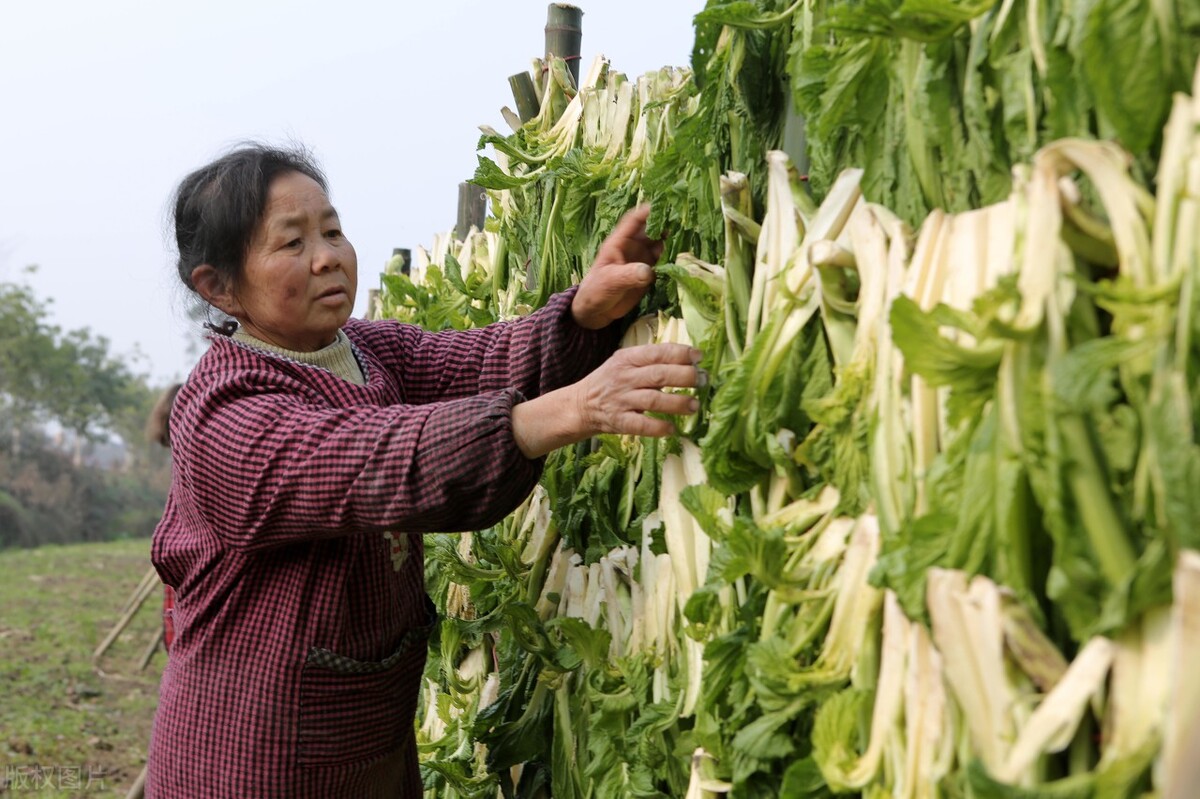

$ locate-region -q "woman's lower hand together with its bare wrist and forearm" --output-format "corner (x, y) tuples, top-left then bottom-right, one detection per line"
(512, 344), (708, 458)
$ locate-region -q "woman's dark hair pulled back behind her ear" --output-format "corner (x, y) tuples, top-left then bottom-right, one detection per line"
(174, 143), (329, 299)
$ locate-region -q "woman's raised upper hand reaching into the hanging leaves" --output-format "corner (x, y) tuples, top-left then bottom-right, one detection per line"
(571, 205), (662, 330)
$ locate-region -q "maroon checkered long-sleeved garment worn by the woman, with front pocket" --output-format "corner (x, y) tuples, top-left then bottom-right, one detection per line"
(146, 290), (618, 799)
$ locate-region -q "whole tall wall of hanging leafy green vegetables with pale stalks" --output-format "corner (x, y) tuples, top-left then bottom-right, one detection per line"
(382, 1), (1200, 798)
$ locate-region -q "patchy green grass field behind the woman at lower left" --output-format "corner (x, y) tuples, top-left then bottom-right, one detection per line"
(0, 540), (166, 799)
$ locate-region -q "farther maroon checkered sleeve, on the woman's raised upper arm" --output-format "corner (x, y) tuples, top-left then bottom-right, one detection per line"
(350, 288), (620, 404)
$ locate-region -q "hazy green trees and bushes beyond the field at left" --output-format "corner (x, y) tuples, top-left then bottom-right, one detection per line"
(0, 271), (170, 548)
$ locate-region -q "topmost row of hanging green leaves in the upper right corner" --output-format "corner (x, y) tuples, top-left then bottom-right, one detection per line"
(787, 0), (1200, 223)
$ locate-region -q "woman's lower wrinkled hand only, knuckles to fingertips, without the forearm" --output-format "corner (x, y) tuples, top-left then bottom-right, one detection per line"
(574, 344), (707, 437)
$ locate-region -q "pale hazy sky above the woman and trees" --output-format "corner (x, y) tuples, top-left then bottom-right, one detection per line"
(0, 0), (704, 385)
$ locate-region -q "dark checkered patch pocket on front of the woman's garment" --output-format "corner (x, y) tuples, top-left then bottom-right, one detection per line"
(298, 597), (437, 768)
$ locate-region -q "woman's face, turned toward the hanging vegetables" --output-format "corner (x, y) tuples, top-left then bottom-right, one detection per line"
(225, 172), (359, 353)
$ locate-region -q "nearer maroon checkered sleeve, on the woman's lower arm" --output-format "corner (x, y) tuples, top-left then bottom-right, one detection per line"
(175, 372), (542, 549)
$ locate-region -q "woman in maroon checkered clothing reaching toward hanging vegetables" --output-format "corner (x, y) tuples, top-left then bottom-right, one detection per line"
(146, 145), (701, 799)
